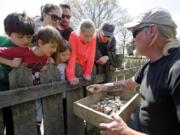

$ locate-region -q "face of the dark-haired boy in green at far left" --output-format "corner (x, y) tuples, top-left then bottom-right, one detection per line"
(9, 32), (32, 47)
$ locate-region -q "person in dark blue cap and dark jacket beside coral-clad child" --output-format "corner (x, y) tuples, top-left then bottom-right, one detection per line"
(95, 23), (116, 73)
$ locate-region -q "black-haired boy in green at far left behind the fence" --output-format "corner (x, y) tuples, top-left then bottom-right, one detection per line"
(0, 12), (34, 135)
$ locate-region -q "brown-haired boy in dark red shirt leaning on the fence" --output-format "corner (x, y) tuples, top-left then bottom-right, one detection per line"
(0, 26), (62, 134)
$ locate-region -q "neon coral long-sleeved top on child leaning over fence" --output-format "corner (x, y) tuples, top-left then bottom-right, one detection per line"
(66, 32), (96, 80)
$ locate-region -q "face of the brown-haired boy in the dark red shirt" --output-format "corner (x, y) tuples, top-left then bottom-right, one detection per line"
(38, 42), (57, 57)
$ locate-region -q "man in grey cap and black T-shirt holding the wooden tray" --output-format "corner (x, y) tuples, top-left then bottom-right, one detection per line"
(87, 8), (180, 135)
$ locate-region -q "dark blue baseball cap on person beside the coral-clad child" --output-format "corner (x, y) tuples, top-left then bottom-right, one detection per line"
(101, 23), (115, 37)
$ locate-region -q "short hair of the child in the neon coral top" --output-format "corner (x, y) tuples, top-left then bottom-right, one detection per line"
(79, 19), (95, 31)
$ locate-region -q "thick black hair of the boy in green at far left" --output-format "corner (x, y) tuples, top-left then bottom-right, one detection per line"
(4, 12), (35, 35)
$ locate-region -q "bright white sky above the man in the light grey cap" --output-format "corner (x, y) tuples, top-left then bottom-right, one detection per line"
(119, 0), (180, 37)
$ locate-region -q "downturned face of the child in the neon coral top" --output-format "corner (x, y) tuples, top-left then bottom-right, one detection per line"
(80, 28), (95, 42)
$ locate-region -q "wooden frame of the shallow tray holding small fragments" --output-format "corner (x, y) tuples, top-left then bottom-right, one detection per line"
(73, 93), (139, 127)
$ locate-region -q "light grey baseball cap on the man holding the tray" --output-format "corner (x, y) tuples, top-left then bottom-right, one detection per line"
(124, 8), (177, 31)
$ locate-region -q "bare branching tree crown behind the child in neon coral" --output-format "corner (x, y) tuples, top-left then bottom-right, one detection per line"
(64, 0), (127, 28)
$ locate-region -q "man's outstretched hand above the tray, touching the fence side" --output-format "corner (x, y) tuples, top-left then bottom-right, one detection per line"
(86, 84), (107, 93)
